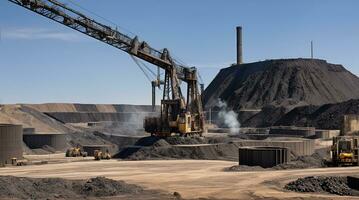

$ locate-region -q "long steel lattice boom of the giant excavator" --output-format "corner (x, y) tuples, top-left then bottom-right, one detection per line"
(9, 0), (191, 81)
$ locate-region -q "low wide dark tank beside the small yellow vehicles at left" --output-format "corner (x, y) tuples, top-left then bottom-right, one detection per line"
(23, 133), (66, 151)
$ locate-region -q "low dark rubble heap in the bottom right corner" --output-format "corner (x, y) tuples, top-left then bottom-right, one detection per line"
(284, 176), (358, 195)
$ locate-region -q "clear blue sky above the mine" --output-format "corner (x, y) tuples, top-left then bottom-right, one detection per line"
(0, 0), (359, 104)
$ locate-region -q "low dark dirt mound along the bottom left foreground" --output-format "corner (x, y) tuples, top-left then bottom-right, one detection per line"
(0, 176), (175, 199)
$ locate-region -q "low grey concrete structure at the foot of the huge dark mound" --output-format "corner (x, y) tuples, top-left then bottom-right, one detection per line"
(269, 126), (315, 137)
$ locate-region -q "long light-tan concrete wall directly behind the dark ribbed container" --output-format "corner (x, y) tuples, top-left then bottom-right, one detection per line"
(233, 138), (314, 156)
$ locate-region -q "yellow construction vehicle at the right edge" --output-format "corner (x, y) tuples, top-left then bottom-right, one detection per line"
(331, 136), (359, 167)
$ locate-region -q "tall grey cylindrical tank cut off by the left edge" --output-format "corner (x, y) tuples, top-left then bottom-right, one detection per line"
(0, 124), (23, 164)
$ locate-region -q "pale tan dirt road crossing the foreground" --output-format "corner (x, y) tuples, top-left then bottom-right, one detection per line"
(0, 160), (359, 199)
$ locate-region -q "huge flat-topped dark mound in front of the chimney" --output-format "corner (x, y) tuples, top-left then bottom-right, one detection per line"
(204, 59), (359, 110)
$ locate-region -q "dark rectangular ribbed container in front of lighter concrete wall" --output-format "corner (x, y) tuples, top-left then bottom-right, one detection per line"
(238, 147), (289, 168)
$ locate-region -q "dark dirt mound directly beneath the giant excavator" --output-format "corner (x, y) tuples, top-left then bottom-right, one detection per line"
(114, 137), (238, 160)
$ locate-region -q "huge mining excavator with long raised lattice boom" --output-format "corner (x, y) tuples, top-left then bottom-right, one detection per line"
(8, 0), (204, 137)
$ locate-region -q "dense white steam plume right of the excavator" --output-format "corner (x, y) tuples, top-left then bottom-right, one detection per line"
(217, 99), (240, 134)
